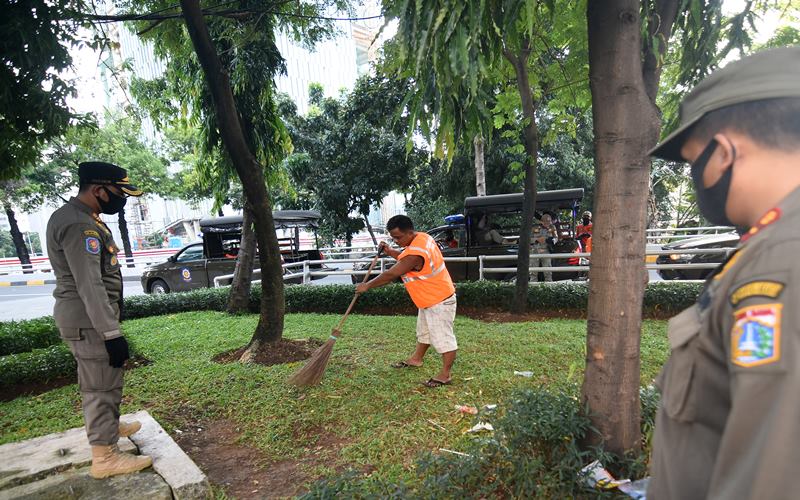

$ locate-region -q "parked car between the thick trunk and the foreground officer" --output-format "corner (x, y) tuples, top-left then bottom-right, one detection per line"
(656, 232), (739, 280)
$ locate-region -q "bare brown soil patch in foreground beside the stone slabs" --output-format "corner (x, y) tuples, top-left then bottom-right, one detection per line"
(175, 420), (354, 498)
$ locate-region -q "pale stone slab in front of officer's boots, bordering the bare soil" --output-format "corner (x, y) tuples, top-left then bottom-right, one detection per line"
(126, 411), (211, 500)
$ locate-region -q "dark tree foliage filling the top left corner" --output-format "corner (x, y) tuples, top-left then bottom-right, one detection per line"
(0, 0), (82, 179)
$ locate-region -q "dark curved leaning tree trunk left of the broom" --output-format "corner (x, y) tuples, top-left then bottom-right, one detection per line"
(181, 0), (286, 362)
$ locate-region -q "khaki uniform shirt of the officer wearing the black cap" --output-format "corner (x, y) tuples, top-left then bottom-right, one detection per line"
(47, 198), (122, 340)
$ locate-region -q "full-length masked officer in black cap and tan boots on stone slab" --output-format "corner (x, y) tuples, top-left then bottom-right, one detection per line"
(47, 162), (152, 479)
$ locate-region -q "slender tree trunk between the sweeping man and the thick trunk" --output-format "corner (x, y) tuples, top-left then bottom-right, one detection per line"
(504, 39), (539, 313)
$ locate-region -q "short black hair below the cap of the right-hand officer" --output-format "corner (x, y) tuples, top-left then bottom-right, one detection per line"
(691, 97), (800, 152)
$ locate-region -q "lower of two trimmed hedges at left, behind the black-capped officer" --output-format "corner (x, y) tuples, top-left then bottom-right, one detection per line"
(0, 344), (77, 386)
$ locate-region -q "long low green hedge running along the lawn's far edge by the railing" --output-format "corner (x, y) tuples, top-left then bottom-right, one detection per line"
(124, 281), (702, 319)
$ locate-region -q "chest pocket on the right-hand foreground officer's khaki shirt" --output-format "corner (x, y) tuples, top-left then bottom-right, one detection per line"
(657, 307), (702, 422)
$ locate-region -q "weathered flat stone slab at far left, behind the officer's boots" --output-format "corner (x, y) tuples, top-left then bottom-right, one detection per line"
(0, 424), (136, 492)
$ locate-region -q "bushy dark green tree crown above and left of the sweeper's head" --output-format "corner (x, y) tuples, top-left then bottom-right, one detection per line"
(280, 76), (425, 240)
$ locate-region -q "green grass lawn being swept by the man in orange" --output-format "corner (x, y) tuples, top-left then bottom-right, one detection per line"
(0, 312), (669, 494)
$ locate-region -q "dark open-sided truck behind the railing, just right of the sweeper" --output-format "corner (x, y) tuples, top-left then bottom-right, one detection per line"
(353, 188), (585, 283)
